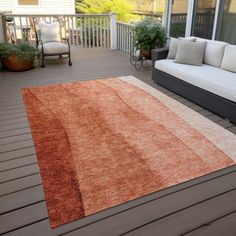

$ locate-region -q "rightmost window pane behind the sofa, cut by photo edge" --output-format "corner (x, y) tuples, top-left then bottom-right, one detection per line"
(219, 0), (236, 44)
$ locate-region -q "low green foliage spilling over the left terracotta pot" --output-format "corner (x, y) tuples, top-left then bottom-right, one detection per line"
(0, 43), (37, 60)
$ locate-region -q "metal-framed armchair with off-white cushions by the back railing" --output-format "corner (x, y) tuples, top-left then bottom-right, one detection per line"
(34, 20), (72, 67)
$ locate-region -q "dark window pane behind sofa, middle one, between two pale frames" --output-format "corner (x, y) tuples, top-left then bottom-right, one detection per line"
(192, 0), (216, 39)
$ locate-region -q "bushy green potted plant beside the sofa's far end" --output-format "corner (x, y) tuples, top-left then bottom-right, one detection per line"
(133, 18), (167, 59)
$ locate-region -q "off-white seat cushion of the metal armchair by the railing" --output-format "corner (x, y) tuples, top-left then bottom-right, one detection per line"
(39, 42), (69, 55)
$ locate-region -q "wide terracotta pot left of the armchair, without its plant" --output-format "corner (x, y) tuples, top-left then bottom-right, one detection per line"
(2, 54), (33, 71)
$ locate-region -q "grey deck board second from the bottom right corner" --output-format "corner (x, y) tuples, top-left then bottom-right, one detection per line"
(123, 189), (236, 236)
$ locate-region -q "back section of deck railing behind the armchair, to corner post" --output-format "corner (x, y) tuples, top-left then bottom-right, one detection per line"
(2, 14), (117, 49)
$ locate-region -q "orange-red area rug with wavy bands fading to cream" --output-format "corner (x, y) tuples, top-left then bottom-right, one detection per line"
(22, 76), (236, 227)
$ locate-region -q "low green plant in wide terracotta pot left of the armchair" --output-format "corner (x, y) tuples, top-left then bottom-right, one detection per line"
(0, 43), (36, 71)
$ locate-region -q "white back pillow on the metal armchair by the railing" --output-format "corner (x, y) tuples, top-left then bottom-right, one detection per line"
(39, 21), (61, 43)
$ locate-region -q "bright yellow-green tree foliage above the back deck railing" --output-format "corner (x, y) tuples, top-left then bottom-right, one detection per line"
(76, 0), (134, 22)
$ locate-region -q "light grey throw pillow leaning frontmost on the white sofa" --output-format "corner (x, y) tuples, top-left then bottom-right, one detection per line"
(175, 40), (206, 66)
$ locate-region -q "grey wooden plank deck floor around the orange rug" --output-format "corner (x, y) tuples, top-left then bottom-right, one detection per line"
(0, 48), (236, 236)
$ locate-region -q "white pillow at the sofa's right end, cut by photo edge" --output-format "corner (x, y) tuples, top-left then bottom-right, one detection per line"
(221, 45), (236, 73)
